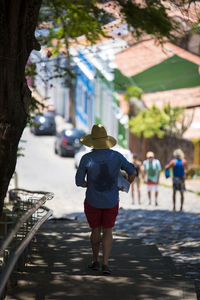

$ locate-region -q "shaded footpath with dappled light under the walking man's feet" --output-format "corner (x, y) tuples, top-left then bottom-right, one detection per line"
(6, 219), (197, 300)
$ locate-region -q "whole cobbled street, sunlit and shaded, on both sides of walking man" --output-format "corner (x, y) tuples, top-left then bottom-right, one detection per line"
(14, 129), (200, 274)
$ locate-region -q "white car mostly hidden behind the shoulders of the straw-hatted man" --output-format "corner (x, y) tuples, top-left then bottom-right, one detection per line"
(74, 145), (132, 169)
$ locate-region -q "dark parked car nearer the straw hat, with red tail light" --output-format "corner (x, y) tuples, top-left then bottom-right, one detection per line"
(54, 128), (85, 156)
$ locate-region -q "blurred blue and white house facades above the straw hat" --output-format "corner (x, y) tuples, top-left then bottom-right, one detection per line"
(74, 41), (128, 148)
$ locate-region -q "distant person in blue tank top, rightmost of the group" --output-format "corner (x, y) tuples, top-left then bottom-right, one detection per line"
(165, 149), (187, 211)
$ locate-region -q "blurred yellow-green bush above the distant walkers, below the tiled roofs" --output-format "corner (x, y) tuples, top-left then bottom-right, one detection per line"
(129, 104), (189, 138)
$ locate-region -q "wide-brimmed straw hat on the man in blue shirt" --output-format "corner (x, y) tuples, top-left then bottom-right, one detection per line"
(80, 124), (117, 149)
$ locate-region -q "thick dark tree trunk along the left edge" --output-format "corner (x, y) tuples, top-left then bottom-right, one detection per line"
(0, 0), (42, 214)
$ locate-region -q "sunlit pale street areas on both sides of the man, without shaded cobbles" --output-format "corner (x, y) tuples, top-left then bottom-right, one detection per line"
(16, 128), (200, 217)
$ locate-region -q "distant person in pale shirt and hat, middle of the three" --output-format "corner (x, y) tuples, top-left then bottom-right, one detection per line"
(143, 151), (161, 206)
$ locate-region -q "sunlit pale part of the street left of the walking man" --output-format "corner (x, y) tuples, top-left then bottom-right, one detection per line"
(16, 128), (84, 217)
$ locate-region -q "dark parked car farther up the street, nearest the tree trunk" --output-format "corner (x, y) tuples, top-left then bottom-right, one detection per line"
(31, 112), (56, 135)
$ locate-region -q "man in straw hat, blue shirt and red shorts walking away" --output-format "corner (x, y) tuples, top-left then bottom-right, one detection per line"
(76, 124), (135, 274)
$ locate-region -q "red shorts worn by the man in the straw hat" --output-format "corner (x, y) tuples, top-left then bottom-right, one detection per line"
(84, 200), (119, 228)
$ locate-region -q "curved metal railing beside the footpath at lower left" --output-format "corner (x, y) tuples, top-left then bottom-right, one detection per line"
(0, 189), (54, 299)
